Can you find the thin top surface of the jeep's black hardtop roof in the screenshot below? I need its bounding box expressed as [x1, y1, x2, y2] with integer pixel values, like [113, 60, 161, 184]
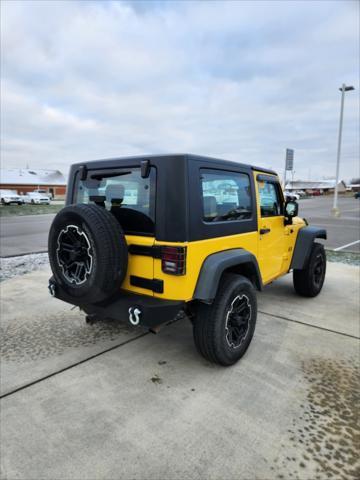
[72, 153, 277, 175]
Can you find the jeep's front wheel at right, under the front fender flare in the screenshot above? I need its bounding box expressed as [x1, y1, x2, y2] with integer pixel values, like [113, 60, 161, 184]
[293, 243, 326, 297]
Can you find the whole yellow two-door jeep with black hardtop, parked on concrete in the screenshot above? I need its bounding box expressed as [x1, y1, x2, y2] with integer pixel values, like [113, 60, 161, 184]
[49, 154, 326, 365]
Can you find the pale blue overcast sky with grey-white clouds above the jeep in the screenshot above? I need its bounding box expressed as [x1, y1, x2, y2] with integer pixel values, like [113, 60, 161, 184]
[1, 0, 359, 180]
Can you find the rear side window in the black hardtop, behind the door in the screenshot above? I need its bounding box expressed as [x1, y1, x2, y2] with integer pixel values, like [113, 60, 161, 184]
[200, 168, 252, 222]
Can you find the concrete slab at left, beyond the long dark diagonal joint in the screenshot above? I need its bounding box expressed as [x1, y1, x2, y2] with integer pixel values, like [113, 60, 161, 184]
[0, 269, 142, 395]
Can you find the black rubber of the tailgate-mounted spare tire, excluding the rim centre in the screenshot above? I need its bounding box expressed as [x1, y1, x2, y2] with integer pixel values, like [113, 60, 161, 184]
[48, 204, 128, 303]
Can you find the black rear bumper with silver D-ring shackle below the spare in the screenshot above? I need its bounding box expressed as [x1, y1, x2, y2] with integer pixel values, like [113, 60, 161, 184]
[49, 277, 185, 328]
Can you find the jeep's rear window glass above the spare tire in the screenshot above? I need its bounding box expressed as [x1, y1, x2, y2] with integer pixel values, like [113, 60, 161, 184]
[75, 167, 156, 235]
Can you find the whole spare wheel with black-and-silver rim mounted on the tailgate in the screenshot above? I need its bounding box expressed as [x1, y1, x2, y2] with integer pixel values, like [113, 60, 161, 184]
[48, 204, 128, 303]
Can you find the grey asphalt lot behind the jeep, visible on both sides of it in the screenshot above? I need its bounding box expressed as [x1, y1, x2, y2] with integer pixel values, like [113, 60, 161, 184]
[0, 196, 360, 257]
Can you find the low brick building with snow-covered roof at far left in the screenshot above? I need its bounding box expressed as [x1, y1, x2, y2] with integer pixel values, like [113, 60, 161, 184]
[0, 168, 66, 199]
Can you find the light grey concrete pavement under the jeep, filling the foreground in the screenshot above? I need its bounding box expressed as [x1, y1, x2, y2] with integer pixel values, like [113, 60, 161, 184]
[0, 263, 360, 480]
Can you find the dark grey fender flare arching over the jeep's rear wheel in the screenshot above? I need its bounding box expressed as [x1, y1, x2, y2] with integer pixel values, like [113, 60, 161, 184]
[193, 248, 263, 302]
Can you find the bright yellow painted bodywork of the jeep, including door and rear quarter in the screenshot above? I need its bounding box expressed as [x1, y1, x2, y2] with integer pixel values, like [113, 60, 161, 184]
[123, 172, 305, 301]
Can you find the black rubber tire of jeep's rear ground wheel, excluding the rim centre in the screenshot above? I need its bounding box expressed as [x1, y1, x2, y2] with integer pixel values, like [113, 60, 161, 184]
[193, 274, 257, 366]
